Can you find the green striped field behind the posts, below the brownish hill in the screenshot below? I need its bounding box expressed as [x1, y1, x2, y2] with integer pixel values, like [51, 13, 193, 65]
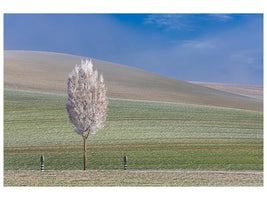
[4, 90, 263, 172]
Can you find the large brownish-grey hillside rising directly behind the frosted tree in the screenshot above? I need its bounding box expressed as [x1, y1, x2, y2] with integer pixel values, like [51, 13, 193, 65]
[4, 51, 263, 111]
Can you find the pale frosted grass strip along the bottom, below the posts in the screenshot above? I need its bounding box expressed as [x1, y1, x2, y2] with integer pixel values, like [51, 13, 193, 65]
[4, 170, 263, 186]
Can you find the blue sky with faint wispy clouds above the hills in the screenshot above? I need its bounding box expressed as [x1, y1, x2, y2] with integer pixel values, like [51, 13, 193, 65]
[4, 14, 263, 85]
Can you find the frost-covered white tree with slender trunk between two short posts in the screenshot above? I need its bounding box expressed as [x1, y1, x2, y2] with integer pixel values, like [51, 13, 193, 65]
[66, 59, 108, 170]
